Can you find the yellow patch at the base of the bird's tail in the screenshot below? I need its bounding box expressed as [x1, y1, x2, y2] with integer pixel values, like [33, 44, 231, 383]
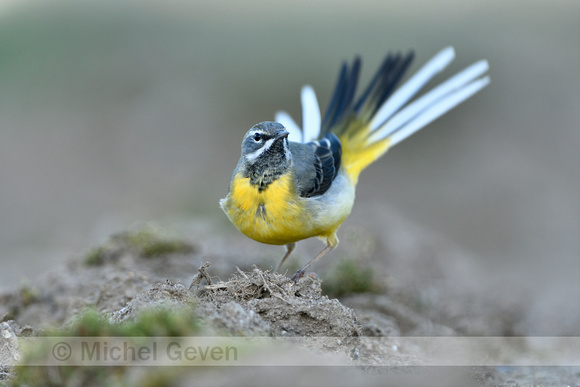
[339, 121, 391, 185]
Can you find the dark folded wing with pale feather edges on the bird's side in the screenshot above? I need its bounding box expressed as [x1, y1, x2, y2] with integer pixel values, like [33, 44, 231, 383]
[299, 133, 342, 198]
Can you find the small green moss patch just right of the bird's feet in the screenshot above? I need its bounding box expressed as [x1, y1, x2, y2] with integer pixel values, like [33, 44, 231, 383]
[322, 258, 381, 297]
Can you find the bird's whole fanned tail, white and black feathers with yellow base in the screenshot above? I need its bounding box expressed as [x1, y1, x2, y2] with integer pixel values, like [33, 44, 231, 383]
[276, 47, 489, 184]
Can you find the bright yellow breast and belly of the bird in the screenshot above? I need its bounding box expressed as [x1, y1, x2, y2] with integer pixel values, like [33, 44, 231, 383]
[220, 175, 328, 245]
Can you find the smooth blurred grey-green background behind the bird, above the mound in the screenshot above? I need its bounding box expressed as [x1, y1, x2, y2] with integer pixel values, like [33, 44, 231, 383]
[0, 0, 580, 326]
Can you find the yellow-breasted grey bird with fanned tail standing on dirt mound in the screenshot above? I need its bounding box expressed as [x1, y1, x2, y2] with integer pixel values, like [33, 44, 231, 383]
[220, 47, 490, 282]
